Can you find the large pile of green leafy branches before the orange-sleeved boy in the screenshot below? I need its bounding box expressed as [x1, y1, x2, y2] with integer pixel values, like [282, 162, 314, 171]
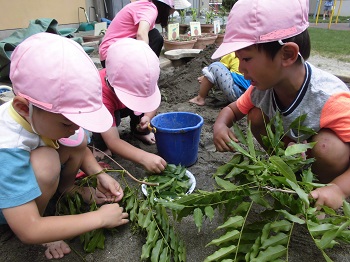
[161, 115, 350, 262]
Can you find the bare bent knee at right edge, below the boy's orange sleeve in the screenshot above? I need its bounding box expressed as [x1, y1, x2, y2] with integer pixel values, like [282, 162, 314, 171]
[311, 129, 350, 183]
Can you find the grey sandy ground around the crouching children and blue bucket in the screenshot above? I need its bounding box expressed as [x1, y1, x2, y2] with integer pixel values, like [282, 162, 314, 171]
[0, 46, 350, 262]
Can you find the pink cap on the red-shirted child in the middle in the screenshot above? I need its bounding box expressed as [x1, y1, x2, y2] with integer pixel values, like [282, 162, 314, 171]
[106, 38, 161, 113]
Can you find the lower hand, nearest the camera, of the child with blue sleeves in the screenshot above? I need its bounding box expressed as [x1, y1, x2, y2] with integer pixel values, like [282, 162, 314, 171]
[96, 204, 129, 228]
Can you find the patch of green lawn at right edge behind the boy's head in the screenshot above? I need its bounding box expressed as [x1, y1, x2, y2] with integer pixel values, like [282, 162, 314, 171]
[308, 27, 350, 62]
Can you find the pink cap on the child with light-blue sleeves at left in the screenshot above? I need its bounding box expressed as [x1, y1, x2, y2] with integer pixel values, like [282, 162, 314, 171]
[10, 33, 112, 132]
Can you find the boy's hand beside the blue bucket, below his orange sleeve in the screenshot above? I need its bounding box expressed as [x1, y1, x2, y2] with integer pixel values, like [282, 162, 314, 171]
[213, 123, 238, 152]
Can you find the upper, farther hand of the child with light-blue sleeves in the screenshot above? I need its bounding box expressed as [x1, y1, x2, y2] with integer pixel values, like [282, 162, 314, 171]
[96, 173, 124, 202]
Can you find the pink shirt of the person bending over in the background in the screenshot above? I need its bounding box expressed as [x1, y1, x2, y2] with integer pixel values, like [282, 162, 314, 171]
[99, 0, 158, 61]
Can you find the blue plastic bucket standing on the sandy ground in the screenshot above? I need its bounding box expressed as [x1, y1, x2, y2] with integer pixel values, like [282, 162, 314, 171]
[151, 112, 204, 167]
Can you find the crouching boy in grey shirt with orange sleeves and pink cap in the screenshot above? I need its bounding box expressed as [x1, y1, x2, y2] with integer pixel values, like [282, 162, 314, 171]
[213, 0, 350, 209]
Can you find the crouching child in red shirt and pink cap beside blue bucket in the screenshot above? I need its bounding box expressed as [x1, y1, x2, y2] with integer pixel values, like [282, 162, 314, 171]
[92, 38, 167, 173]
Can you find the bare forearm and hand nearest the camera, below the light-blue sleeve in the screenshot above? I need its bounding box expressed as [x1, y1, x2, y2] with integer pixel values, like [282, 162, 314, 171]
[2, 201, 129, 244]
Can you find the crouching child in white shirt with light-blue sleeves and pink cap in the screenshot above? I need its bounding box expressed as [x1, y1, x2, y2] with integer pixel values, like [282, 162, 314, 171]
[0, 33, 128, 259]
